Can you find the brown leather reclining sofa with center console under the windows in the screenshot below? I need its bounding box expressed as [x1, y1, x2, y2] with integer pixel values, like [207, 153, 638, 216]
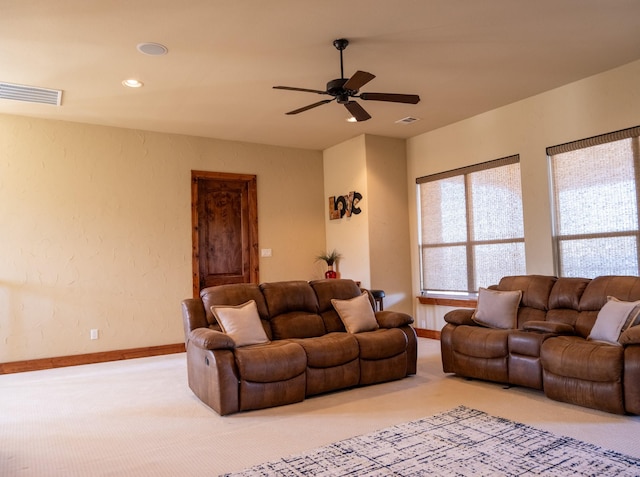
[441, 275, 640, 414]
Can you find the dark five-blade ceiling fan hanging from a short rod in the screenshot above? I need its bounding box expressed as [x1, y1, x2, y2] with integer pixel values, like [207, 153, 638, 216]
[274, 38, 420, 122]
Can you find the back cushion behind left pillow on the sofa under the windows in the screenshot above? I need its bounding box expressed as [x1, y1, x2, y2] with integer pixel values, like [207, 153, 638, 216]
[496, 275, 557, 328]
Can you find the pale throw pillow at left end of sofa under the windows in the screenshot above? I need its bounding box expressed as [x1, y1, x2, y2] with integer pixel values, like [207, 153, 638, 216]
[472, 288, 522, 330]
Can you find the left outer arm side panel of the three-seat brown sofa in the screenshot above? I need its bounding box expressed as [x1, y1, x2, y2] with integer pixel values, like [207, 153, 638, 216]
[187, 344, 240, 416]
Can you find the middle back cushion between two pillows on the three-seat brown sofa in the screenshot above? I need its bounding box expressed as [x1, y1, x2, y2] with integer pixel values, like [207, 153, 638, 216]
[260, 280, 326, 339]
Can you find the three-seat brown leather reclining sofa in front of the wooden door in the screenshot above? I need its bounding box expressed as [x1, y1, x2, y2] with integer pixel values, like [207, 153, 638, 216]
[182, 279, 417, 415]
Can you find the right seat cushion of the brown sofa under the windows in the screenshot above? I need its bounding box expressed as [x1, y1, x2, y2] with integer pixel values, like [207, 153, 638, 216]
[540, 336, 624, 382]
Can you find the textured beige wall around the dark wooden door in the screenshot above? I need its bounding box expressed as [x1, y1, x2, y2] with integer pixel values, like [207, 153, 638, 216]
[0, 116, 326, 362]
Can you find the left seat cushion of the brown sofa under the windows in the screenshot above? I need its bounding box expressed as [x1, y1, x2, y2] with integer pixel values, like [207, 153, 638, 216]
[452, 325, 511, 359]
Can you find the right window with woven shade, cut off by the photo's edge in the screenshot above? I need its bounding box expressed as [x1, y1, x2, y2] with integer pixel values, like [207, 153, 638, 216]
[547, 127, 640, 278]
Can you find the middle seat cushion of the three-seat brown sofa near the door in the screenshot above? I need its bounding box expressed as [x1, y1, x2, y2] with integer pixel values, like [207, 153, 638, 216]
[294, 333, 359, 368]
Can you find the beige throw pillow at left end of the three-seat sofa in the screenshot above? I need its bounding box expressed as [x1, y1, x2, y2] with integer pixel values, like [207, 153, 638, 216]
[211, 300, 269, 347]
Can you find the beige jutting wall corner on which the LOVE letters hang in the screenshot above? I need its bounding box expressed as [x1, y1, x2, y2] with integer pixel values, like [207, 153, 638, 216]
[324, 135, 413, 313]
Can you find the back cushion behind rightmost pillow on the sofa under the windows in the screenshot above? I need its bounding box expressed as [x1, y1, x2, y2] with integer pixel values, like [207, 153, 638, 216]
[575, 275, 640, 338]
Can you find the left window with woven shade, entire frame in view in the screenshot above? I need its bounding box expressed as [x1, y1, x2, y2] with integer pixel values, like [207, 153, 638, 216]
[416, 155, 526, 293]
